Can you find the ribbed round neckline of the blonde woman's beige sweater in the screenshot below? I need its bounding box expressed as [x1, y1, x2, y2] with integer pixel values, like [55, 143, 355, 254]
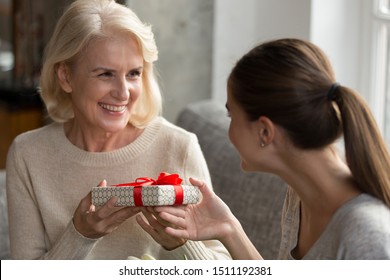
[55, 117, 162, 167]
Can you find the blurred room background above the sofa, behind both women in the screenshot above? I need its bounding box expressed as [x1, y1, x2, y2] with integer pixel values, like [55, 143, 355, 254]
[0, 0, 390, 169]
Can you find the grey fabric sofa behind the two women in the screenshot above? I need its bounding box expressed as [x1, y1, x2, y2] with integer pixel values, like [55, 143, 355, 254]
[0, 100, 286, 259]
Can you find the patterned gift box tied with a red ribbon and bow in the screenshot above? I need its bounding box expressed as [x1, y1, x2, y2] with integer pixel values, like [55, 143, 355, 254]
[92, 173, 201, 206]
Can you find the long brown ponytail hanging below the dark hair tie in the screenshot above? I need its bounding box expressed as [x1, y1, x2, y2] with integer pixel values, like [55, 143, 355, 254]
[334, 86, 390, 207]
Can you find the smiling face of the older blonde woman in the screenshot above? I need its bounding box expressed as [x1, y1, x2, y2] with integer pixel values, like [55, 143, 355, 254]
[62, 32, 143, 132]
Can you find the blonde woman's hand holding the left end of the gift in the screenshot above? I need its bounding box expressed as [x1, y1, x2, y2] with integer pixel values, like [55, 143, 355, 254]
[73, 180, 140, 238]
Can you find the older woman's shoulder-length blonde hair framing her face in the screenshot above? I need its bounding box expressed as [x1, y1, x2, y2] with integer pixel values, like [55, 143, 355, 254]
[40, 0, 162, 127]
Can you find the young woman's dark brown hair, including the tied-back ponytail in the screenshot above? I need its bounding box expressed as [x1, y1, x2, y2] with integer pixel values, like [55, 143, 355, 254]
[228, 39, 390, 206]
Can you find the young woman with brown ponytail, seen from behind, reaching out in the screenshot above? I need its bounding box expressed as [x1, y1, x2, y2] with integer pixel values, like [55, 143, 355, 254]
[153, 39, 390, 259]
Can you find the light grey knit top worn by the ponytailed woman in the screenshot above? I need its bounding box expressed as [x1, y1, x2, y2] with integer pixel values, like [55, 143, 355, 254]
[279, 188, 390, 260]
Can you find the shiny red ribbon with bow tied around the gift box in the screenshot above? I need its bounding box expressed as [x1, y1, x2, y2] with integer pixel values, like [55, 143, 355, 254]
[114, 172, 184, 206]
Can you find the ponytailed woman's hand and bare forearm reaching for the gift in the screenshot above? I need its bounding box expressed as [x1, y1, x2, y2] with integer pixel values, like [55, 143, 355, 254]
[155, 179, 262, 260]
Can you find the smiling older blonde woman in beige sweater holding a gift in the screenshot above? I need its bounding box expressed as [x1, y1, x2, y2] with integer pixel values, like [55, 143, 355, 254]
[7, 0, 230, 259]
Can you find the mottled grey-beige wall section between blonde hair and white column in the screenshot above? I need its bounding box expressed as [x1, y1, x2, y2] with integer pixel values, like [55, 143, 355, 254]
[127, 0, 214, 121]
